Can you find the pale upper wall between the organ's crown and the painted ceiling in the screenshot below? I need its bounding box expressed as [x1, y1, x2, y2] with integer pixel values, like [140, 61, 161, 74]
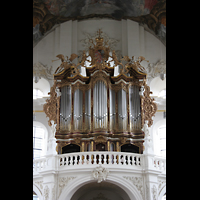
[33, 19, 166, 78]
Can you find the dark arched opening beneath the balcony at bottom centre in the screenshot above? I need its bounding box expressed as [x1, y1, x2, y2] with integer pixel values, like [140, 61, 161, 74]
[71, 182, 130, 200]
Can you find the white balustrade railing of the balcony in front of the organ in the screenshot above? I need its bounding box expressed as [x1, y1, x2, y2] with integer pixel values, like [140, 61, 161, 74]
[33, 151, 166, 173]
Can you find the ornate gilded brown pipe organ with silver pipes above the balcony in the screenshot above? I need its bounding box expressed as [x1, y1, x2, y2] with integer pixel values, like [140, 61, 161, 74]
[43, 30, 157, 154]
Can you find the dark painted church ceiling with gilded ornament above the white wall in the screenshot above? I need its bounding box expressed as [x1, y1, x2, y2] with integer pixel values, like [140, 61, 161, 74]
[33, 0, 166, 46]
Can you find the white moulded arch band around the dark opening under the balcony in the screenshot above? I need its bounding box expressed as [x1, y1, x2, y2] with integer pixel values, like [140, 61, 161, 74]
[58, 175, 143, 200]
